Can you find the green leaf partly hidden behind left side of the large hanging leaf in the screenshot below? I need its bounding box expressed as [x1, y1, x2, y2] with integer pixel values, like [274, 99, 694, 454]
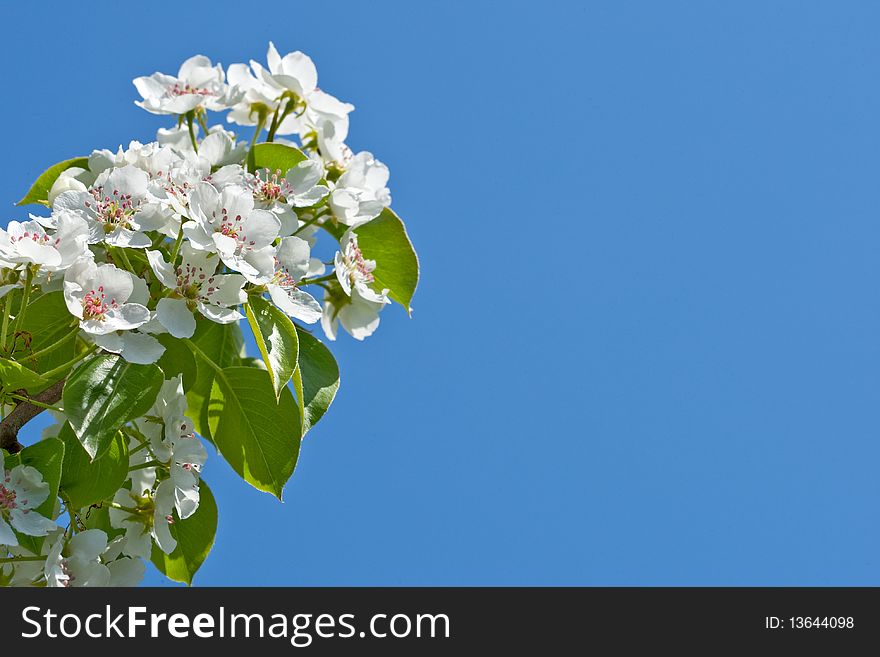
[186, 318, 244, 440]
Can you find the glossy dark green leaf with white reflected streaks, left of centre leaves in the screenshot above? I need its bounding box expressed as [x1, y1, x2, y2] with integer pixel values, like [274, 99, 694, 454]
[62, 354, 164, 460]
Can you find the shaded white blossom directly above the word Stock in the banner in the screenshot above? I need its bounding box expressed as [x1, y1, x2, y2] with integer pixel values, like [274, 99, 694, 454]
[45, 529, 110, 588]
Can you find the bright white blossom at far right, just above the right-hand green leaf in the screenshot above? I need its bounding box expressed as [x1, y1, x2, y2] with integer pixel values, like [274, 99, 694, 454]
[330, 151, 391, 227]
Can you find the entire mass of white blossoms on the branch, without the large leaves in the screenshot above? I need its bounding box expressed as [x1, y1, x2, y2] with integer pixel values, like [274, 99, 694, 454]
[0, 43, 414, 586]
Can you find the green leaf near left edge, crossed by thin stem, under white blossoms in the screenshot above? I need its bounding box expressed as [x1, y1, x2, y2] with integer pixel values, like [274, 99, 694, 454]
[15, 291, 79, 373]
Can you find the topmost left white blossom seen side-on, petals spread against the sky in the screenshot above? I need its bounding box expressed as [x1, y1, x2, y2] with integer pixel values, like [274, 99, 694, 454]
[132, 55, 242, 114]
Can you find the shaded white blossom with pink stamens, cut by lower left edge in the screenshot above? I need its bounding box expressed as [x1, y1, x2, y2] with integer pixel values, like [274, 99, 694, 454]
[0, 450, 56, 546]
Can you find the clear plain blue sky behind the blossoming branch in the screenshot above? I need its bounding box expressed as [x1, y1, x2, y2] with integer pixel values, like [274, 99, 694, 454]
[0, 1, 880, 585]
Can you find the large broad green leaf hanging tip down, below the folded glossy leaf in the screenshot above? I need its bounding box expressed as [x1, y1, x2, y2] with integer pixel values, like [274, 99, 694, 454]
[208, 367, 301, 499]
